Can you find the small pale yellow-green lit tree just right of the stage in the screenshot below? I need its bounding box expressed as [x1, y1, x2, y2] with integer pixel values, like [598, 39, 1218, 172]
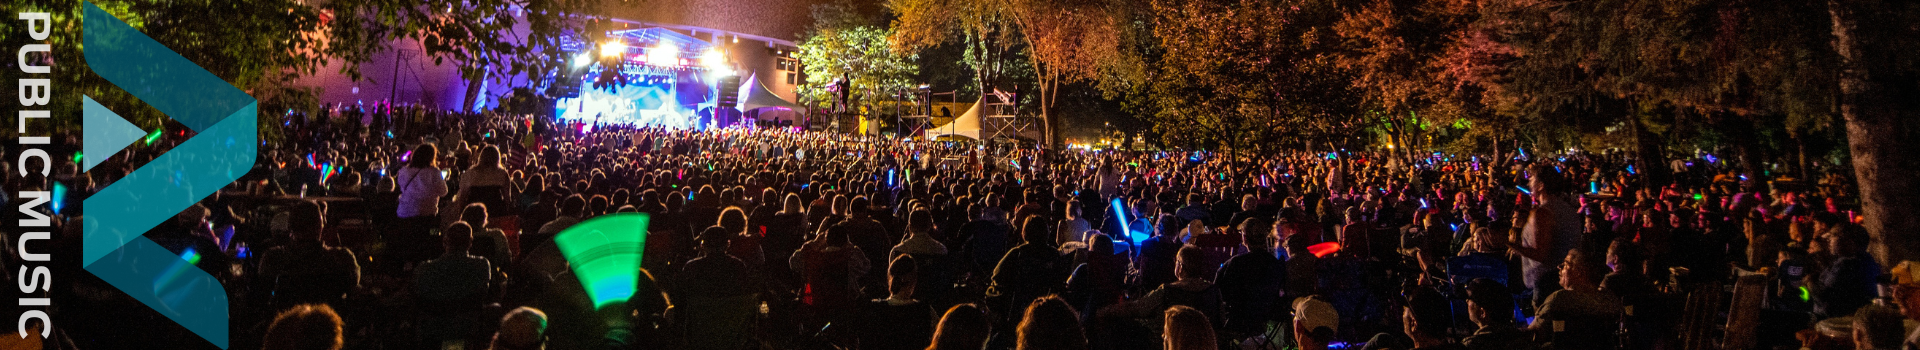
[799, 2, 920, 125]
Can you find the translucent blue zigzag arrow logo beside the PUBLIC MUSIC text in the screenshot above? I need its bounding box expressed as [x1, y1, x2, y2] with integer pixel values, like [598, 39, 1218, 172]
[81, 2, 259, 348]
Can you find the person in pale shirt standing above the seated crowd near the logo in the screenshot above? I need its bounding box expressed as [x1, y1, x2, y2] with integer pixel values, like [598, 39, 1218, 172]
[392, 144, 447, 262]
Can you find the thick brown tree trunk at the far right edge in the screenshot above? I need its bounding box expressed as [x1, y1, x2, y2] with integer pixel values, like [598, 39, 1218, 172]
[1826, 0, 1920, 267]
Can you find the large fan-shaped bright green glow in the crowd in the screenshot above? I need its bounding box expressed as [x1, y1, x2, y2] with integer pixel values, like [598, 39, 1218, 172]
[553, 213, 651, 308]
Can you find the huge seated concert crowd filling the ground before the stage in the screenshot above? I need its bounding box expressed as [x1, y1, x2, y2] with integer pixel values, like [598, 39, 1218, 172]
[0, 106, 1920, 350]
